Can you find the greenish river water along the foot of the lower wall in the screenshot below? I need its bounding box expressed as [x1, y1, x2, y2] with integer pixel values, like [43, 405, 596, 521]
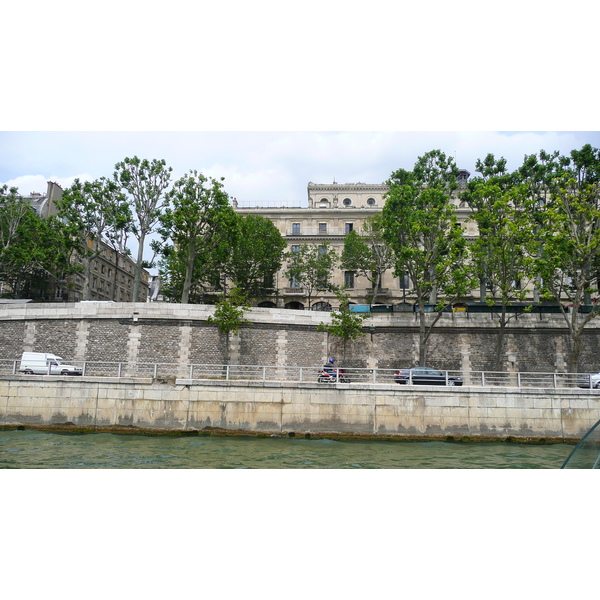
[0, 430, 574, 469]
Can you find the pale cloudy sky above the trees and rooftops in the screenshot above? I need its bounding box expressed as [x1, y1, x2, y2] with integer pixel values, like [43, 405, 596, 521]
[0, 131, 600, 206]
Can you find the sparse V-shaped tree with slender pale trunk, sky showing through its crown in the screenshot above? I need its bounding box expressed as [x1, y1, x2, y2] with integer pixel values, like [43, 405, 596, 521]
[114, 156, 173, 302]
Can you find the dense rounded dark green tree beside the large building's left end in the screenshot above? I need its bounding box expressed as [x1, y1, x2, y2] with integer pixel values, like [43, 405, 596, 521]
[225, 215, 286, 298]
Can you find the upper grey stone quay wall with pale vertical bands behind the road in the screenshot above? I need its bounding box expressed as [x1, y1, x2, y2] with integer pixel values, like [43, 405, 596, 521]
[0, 302, 600, 373]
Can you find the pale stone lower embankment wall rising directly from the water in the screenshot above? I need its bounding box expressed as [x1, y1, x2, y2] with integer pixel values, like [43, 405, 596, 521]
[0, 375, 600, 441]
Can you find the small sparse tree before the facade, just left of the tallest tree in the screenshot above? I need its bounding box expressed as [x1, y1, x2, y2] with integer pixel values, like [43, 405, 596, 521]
[340, 215, 394, 304]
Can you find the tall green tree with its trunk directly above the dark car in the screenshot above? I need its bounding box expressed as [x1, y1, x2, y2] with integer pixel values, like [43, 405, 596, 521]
[382, 150, 473, 365]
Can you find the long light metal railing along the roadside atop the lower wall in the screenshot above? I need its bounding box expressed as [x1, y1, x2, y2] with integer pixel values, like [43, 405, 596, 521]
[0, 359, 600, 389]
